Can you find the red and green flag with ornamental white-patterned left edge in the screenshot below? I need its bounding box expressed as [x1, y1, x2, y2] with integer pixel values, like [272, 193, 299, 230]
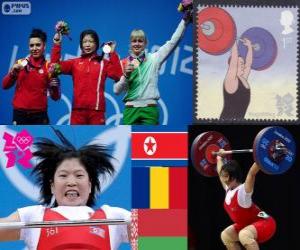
[131, 209, 187, 250]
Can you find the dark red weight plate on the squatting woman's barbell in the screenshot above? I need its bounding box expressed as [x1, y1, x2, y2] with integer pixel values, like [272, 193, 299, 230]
[191, 131, 231, 177]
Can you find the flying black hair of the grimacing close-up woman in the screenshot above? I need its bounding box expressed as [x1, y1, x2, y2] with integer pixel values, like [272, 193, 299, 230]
[32, 129, 115, 206]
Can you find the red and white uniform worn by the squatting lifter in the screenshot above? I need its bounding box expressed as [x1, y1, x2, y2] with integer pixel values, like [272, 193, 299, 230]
[224, 184, 276, 243]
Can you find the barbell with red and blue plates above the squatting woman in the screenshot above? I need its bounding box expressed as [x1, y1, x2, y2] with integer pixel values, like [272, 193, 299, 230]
[191, 126, 296, 177]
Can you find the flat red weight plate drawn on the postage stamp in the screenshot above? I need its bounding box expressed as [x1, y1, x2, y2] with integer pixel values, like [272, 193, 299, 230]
[197, 7, 236, 55]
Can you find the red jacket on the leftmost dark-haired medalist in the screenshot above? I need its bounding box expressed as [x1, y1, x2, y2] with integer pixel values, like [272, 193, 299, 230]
[2, 56, 60, 111]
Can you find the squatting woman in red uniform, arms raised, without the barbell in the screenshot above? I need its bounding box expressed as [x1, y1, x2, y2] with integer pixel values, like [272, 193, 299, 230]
[217, 153, 276, 250]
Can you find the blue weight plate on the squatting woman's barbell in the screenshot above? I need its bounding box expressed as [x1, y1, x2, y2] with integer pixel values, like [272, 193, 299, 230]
[253, 126, 296, 174]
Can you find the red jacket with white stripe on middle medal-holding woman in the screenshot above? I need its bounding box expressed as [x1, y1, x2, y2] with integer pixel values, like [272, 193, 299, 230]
[52, 44, 123, 124]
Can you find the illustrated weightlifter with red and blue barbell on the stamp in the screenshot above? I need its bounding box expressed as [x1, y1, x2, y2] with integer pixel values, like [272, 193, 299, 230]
[197, 7, 277, 119]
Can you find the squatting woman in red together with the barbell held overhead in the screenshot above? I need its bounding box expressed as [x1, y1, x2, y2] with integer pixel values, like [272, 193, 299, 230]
[191, 127, 296, 250]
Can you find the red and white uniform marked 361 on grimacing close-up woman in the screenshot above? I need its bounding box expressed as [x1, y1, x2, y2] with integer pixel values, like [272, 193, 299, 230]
[18, 205, 130, 250]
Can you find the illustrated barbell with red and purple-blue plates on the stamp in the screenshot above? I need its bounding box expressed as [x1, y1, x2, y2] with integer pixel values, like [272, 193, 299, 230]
[197, 7, 278, 70]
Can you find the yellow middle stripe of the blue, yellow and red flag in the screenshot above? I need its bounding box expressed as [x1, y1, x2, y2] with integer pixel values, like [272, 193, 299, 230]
[150, 167, 169, 208]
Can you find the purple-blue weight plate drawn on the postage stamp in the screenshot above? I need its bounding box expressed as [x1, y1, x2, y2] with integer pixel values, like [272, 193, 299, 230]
[238, 27, 278, 70]
